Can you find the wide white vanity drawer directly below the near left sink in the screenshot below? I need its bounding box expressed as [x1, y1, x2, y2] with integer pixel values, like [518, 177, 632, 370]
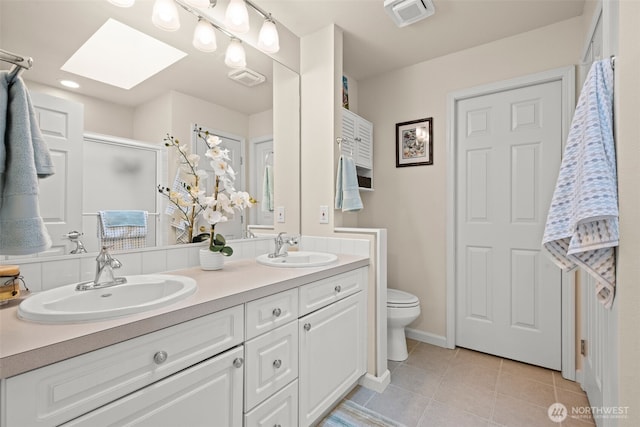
[5, 305, 244, 426]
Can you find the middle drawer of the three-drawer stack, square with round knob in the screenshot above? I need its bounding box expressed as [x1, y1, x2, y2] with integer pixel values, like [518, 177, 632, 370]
[244, 322, 298, 411]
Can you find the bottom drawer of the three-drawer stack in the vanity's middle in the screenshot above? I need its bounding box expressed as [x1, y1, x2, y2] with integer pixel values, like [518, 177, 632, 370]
[244, 380, 298, 427]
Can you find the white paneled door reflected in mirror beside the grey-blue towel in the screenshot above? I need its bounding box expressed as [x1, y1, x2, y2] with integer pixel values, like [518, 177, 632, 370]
[31, 92, 84, 256]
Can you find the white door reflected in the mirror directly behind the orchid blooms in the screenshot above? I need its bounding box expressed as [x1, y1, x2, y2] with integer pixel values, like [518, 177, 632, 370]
[191, 126, 246, 240]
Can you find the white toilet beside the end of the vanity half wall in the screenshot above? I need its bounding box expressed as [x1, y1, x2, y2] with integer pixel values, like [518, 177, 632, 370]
[387, 288, 420, 362]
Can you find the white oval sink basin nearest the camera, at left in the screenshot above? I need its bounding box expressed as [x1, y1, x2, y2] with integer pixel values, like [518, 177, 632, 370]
[18, 274, 197, 323]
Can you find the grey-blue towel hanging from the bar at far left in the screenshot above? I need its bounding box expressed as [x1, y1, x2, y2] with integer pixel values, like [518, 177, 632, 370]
[0, 71, 54, 255]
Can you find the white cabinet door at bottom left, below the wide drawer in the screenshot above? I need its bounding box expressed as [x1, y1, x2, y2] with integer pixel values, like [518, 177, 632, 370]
[63, 346, 243, 427]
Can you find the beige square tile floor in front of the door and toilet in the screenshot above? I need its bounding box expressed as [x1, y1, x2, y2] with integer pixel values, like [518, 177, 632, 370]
[346, 340, 595, 427]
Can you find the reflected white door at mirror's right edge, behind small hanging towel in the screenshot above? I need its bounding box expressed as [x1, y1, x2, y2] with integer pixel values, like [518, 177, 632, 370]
[249, 139, 274, 226]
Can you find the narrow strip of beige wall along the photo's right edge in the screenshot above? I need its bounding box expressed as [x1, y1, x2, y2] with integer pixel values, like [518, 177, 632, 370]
[614, 0, 640, 427]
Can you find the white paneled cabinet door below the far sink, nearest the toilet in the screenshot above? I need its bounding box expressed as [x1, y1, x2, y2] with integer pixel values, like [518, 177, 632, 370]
[298, 292, 367, 426]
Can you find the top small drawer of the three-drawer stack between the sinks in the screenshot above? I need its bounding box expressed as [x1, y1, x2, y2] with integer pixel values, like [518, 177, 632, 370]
[245, 288, 298, 340]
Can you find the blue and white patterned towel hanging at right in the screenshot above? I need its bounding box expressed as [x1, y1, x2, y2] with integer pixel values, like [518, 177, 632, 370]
[542, 59, 618, 308]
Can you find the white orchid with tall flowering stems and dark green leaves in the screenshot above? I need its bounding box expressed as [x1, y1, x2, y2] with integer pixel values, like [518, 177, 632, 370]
[158, 126, 256, 256]
